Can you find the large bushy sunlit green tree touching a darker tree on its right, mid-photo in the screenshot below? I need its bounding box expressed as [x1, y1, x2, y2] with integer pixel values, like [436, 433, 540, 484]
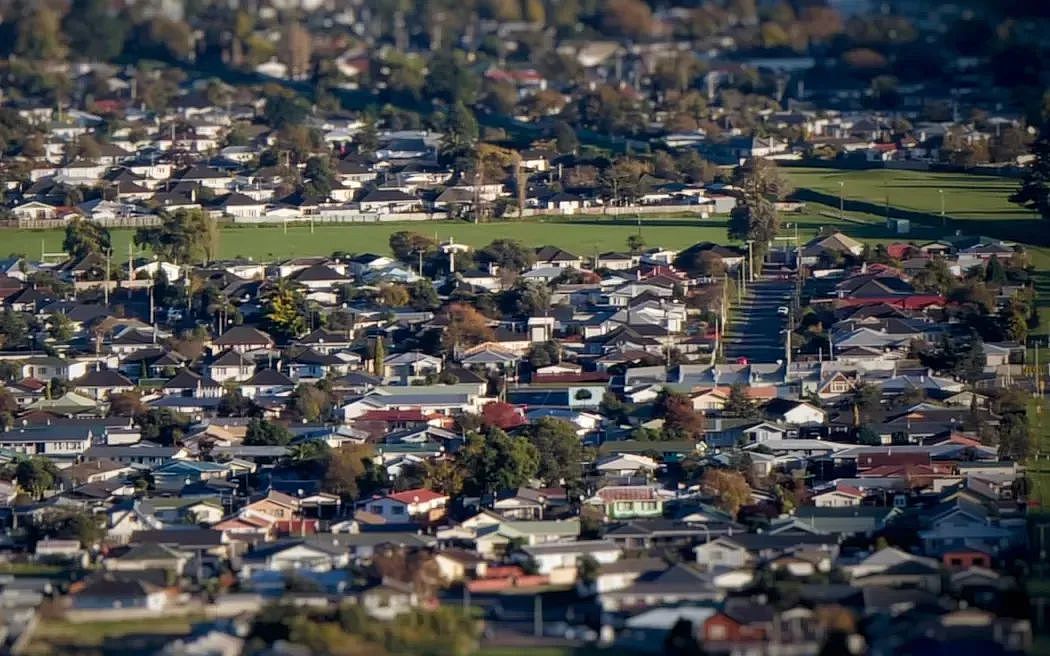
[459, 428, 540, 495]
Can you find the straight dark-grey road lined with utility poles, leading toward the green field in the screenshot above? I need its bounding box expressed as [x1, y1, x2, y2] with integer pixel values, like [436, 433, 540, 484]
[726, 277, 795, 362]
